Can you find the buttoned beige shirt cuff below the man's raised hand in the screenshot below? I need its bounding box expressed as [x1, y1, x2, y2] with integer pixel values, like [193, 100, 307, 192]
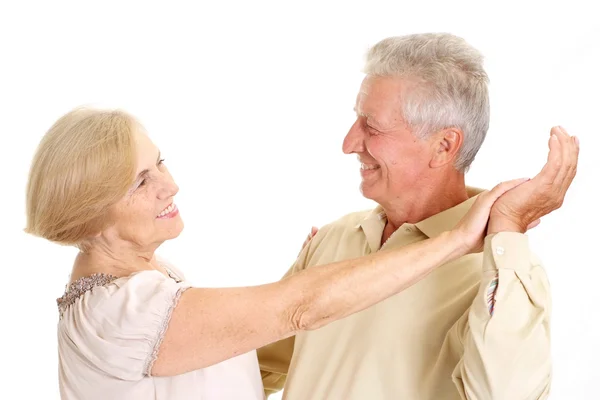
[483, 232, 531, 272]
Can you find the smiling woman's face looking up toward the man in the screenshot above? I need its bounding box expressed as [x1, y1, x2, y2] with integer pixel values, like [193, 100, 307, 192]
[108, 130, 183, 249]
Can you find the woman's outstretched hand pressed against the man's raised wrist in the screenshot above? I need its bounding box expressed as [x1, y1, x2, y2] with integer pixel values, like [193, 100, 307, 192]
[450, 178, 540, 254]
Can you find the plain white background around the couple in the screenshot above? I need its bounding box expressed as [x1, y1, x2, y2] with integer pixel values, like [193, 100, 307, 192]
[0, 0, 600, 400]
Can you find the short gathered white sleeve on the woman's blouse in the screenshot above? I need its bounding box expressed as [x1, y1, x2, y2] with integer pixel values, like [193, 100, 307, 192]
[67, 271, 190, 380]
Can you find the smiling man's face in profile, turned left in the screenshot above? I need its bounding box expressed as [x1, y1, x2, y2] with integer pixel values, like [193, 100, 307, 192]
[343, 76, 432, 205]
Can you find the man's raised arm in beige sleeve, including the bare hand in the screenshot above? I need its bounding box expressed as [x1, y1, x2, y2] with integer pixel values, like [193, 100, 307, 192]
[453, 127, 579, 400]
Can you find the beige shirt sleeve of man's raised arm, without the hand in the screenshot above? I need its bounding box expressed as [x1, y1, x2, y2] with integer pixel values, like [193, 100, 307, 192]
[452, 232, 552, 400]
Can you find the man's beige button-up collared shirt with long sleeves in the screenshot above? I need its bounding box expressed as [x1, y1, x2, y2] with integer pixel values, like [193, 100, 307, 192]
[258, 191, 551, 400]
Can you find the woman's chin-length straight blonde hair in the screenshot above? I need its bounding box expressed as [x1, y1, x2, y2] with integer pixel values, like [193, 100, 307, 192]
[25, 108, 140, 248]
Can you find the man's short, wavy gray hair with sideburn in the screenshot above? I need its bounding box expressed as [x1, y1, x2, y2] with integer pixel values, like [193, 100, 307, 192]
[364, 33, 490, 172]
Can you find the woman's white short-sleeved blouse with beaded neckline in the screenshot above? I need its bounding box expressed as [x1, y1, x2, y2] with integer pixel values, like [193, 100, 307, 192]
[58, 266, 265, 400]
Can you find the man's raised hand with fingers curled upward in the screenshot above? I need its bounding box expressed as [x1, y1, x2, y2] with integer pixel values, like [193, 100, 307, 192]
[488, 127, 579, 235]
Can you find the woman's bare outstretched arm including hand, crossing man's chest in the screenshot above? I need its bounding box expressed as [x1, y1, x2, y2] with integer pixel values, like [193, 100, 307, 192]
[151, 180, 523, 376]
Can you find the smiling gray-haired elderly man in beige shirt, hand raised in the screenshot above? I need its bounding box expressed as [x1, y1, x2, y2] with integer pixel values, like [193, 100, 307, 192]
[259, 34, 579, 400]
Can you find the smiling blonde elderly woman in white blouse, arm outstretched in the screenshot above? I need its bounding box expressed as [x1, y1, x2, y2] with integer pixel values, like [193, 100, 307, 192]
[26, 109, 523, 400]
